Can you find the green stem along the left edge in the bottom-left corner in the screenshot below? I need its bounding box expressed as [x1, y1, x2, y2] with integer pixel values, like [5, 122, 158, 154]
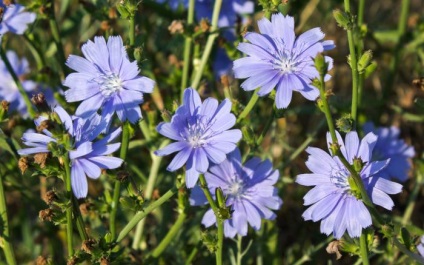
[0, 170, 17, 265]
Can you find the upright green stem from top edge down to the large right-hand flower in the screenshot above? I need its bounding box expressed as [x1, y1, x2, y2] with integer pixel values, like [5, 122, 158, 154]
[344, 0, 359, 128]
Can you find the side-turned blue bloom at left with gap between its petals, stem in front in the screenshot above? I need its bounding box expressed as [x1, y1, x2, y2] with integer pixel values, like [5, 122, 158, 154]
[18, 107, 123, 198]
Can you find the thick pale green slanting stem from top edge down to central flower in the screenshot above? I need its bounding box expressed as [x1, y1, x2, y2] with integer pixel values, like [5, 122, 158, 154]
[191, 0, 222, 89]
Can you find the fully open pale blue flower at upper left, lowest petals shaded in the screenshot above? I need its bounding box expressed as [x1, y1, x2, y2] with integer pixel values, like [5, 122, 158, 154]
[64, 36, 155, 123]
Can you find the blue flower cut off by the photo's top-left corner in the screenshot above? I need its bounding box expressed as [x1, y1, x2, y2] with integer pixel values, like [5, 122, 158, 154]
[0, 0, 36, 35]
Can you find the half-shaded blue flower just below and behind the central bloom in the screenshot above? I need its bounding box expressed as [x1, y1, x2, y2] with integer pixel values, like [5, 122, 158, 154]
[190, 149, 283, 237]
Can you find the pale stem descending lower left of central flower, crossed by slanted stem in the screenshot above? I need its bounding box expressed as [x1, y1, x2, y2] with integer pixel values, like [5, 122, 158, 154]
[132, 140, 169, 249]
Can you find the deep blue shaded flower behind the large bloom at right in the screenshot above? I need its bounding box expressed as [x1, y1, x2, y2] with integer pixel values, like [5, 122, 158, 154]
[364, 122, 415, 182]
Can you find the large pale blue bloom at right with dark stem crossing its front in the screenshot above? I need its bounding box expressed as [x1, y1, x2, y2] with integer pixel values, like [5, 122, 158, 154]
[296, 131, 402, 239]
